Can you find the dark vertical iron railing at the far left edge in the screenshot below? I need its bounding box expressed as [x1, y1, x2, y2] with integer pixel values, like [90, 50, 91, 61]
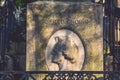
[0, 0, 15, 70]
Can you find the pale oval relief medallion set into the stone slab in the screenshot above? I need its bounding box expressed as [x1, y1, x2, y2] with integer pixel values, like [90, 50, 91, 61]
[46, 29, 85, 71]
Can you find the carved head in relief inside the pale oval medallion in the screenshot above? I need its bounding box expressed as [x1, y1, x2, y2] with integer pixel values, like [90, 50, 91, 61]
[51, 36, 78, 70]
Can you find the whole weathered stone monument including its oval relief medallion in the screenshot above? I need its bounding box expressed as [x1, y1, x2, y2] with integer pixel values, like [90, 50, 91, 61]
[26, 1, 103, 71]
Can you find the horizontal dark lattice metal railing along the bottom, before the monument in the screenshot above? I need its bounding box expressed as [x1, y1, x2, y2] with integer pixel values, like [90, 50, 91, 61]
[0, 71, 120, 80]
